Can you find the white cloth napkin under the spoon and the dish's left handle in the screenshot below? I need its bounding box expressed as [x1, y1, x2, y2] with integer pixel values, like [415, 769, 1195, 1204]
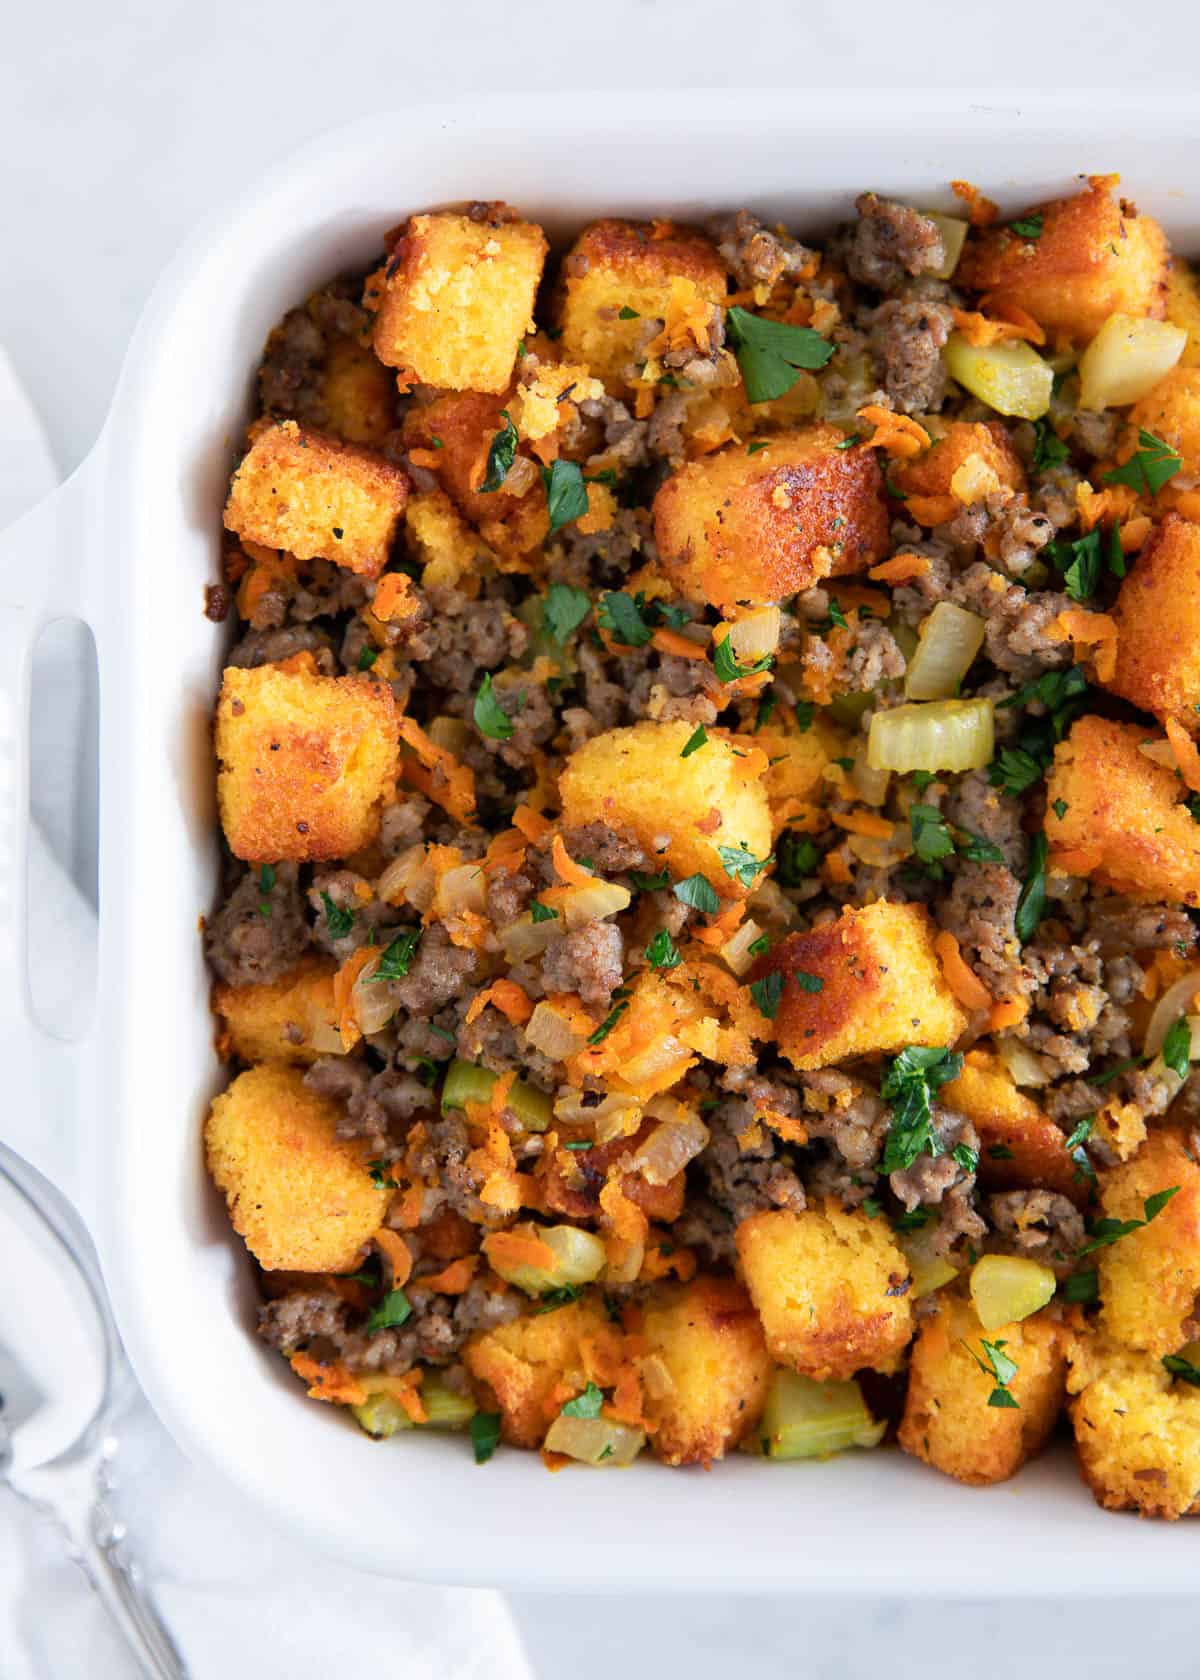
[0, 349, 531, 1680]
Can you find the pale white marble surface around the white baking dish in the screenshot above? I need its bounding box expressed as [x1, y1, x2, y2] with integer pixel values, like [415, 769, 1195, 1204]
[0, 0, 1198, 1680]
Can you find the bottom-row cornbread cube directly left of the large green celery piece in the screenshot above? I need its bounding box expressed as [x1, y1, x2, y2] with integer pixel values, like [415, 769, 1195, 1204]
[642, 1277, 771, 1465]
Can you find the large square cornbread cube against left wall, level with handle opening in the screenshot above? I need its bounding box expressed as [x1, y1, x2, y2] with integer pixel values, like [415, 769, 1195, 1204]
[217, 654, 397, 864]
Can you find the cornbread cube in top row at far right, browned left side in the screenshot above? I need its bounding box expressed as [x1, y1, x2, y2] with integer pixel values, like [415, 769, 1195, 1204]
[955, 176, 1168, 343]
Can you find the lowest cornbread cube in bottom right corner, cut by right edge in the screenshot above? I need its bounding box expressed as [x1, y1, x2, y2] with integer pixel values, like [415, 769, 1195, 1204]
[1067, 1334, 1200, 1522]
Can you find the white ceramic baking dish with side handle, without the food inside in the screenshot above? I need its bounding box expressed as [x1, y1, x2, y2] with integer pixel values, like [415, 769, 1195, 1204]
[0, 89, 1200, 1585]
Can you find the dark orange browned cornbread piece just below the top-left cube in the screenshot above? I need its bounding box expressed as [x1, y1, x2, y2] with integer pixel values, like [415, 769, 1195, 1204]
[403, 391, 550, 554]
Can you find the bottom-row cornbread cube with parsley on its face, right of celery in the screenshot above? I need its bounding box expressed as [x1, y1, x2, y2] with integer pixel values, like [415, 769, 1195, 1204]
[899, 1292, 1066, 1487]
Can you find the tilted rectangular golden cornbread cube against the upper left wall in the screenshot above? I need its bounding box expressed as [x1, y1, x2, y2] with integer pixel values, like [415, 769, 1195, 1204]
[225, 420, 408, 578]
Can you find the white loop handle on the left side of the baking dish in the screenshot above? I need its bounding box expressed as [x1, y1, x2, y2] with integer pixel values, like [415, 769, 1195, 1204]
[0, 455, 99, 1201]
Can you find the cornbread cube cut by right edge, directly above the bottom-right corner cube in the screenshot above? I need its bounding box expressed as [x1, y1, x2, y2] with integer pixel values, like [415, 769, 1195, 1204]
[1096, 1126, 1200, 1356]
